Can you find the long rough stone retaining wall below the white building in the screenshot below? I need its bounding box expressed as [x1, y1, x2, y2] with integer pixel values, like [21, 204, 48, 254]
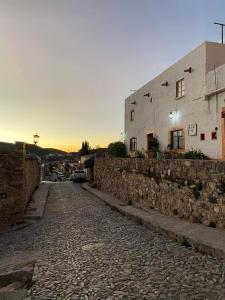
[94, 158, 225, 228]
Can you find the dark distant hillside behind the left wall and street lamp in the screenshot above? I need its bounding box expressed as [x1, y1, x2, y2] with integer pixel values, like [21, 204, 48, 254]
[0, 142, 67, 158]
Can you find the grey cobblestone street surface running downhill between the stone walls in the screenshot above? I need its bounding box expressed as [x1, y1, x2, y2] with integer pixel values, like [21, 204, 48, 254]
[0, 182, 225, 300]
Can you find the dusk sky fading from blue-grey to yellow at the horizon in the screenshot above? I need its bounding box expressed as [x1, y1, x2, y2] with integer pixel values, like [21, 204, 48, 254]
[0, 0, 225, 151]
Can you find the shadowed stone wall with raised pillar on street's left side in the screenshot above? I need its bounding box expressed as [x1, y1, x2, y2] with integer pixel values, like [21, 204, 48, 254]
[0, 143, 40, 230]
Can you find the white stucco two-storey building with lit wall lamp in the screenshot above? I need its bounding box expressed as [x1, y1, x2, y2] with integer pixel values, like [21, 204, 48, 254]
[125, 42, 225, 159]
